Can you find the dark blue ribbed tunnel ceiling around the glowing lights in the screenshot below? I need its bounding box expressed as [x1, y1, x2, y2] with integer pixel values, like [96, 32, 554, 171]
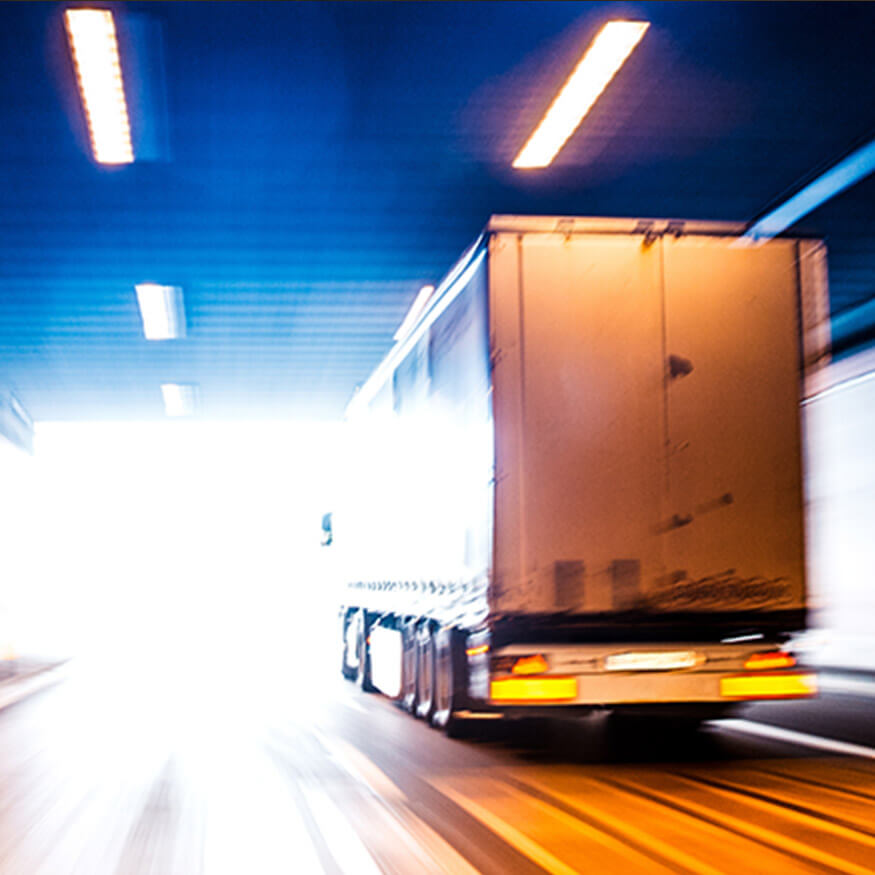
[0, 3, 875, 420]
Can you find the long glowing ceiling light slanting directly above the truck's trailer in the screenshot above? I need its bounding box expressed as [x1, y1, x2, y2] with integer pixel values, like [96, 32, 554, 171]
[513, 21, 650, 169]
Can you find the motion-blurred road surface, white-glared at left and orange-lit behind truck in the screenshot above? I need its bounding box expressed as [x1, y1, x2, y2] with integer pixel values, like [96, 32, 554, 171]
[0, 665, 875, 875]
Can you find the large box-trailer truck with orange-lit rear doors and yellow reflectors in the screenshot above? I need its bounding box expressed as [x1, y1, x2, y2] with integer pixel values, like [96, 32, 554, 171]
[323, 216, 829, 733]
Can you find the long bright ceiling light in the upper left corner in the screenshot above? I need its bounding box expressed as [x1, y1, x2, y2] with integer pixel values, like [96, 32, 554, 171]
[64, 9, 134, 164]
